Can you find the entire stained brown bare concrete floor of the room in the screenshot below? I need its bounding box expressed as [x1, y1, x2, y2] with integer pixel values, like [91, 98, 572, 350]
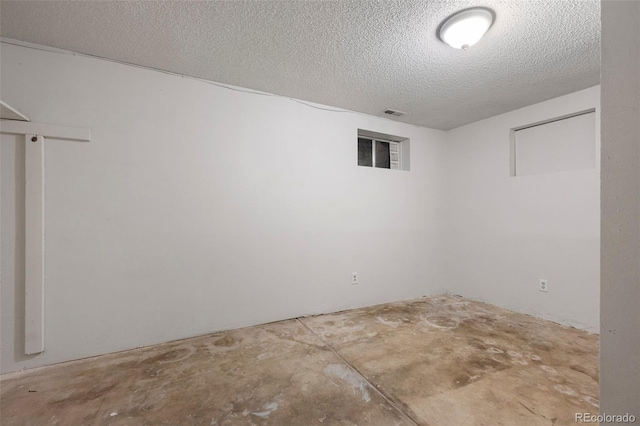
[0, 296, 598, 426]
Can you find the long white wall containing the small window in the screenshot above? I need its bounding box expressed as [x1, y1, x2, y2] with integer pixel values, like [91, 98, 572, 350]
[0, 44, 446, 373]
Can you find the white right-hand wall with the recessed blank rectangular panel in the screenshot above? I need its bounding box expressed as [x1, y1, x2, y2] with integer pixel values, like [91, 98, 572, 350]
[446, 87, 600, 332]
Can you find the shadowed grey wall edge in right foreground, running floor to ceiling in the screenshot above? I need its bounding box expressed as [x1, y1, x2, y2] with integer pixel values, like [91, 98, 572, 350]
[600, 1, 640, 414]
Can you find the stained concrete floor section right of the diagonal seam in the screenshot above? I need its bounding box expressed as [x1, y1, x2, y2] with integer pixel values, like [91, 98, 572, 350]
[302, 295, 598, 426]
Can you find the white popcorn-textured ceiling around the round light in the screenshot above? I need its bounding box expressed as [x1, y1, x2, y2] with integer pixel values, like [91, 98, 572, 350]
[0, 0, 600, 130]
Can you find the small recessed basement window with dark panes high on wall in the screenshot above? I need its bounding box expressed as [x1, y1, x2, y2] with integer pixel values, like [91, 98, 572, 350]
[358, 130, 409, 170]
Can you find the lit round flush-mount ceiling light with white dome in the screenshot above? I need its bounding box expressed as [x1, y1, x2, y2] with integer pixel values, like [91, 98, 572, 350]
[438, 7, 495, 50]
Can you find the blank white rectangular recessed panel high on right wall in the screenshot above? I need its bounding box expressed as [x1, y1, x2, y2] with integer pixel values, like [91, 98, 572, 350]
[512, 110, 596, 176]
